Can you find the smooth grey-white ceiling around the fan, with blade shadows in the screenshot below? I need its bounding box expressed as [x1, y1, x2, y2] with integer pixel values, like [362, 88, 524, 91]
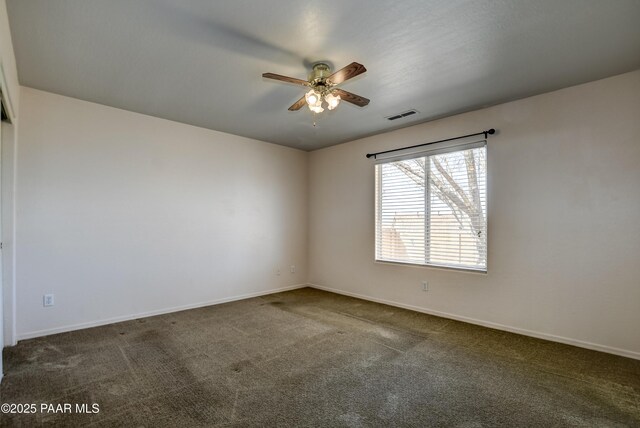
[7, 0, 640, 150]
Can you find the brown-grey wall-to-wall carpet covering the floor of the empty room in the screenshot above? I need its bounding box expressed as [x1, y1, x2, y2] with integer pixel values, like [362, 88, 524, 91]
[0, 288, 640, 428]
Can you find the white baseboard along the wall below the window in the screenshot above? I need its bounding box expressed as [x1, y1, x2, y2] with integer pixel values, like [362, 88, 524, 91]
[307, 284, 640, 360]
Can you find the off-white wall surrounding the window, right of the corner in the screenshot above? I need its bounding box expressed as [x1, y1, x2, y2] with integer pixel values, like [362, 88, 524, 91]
[309, 71, 640, 358]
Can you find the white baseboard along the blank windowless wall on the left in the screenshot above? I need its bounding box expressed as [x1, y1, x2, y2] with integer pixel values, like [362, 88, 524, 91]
[17, 284, 308, 341]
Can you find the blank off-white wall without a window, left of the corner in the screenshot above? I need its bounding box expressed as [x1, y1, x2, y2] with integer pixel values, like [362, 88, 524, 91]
[16, 87, 308, 338]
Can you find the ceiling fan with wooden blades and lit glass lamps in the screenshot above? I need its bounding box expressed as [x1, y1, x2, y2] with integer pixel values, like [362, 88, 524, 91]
[262, 62, 369, 113]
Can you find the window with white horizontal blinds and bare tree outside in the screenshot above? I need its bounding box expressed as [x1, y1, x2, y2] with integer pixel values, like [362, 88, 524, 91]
[376, 141, 487, 271]
